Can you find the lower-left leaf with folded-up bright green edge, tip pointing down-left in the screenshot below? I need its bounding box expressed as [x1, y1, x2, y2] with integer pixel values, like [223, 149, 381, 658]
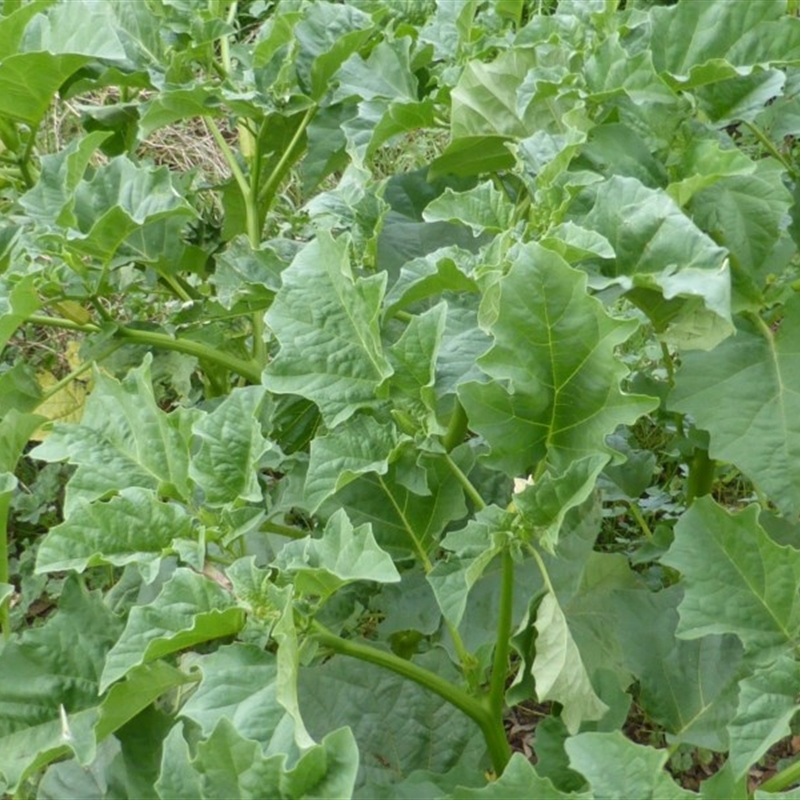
[100, 568, 244, 691]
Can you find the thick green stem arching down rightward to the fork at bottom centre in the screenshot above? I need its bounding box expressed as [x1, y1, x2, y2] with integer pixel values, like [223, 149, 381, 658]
[312, 621, 511, 775]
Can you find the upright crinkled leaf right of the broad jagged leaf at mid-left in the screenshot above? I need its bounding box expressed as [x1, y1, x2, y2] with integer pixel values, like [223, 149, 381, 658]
[189, 386, 277, 507]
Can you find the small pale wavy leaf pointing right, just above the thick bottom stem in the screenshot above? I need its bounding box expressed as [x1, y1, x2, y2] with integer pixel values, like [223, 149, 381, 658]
[274, 510, 400, 600]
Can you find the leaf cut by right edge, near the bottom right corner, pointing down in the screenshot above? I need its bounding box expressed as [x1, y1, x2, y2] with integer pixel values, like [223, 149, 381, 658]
[728, 654, 800, 778]
